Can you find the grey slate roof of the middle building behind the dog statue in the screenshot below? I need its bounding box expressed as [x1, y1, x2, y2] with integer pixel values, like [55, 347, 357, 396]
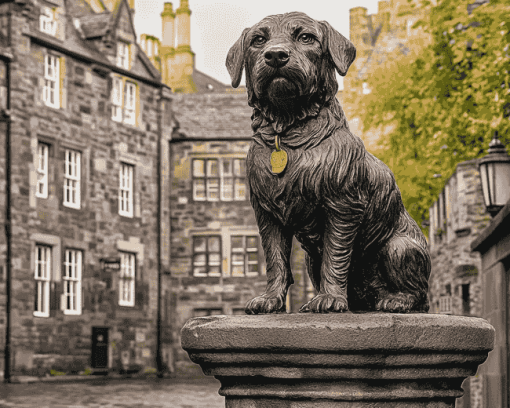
[172, 93, 253, 140]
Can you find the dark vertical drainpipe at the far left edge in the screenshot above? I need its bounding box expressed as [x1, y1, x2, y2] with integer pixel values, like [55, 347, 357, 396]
[0, 5, 12, 383]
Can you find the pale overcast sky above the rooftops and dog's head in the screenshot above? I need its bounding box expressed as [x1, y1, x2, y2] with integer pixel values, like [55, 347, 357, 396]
[134, 0, 378, 87]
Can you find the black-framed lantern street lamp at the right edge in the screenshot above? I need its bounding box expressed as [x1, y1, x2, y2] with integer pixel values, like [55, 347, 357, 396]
[480, 130, 510, 217]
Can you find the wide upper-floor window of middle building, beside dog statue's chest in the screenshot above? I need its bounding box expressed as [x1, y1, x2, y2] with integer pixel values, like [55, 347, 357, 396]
[193, 158, 246, 201]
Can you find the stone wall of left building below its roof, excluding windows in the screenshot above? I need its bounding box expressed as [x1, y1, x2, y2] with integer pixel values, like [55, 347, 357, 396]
[0, 0, 171, 375]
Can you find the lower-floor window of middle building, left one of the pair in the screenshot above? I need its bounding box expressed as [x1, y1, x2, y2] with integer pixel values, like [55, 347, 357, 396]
[193, 235, 221, 276]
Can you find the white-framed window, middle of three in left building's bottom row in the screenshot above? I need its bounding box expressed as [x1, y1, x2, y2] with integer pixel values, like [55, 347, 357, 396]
[61, 249, 82, 315]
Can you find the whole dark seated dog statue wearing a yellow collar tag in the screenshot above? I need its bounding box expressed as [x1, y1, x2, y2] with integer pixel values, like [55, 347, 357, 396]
[226, 12, 430, 314]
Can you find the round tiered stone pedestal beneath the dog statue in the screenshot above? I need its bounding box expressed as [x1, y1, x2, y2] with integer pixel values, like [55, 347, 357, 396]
[182, 313, 494, 408]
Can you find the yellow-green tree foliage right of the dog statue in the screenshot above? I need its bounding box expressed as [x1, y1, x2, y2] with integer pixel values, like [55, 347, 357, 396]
[344, 0, 510, 230]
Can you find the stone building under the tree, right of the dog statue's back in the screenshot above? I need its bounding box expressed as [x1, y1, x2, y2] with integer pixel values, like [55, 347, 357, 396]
[429, 160, 490, 408]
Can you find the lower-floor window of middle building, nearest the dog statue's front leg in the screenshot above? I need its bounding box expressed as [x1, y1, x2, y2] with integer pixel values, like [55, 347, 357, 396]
[230, 235, 259, 276]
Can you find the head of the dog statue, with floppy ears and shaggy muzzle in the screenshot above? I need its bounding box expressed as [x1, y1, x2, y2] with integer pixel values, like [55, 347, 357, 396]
[226, 12, 356, 133]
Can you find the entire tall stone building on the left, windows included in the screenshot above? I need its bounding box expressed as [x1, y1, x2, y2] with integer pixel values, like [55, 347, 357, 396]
[0, 0, 172, 377]
